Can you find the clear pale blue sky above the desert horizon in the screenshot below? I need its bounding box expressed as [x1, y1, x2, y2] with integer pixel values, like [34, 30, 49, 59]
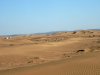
[0, 0, 100, 35]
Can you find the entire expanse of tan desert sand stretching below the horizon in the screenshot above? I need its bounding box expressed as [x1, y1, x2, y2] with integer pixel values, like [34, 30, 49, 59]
[0, 30, 100, 75]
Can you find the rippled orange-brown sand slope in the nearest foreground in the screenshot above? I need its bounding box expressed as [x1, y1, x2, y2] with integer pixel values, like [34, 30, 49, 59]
[0, 52, 100, 75]
